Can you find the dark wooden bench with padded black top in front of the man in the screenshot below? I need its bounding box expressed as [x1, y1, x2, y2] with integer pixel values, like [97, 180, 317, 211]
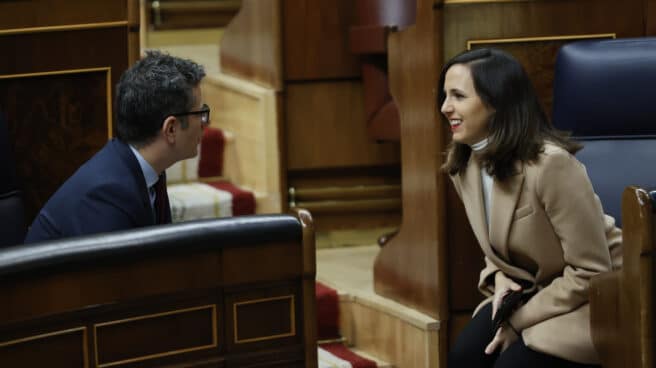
[0, 211, 317, 367]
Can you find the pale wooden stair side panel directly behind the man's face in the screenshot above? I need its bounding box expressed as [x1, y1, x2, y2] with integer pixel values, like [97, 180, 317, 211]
[201, 74, 283, 213]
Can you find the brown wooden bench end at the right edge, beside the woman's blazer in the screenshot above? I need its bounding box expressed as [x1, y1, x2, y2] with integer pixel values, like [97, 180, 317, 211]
[590, 186, 656, 368]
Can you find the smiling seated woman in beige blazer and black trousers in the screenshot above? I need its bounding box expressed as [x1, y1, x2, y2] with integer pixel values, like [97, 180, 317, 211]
[439, 49, 621, 368]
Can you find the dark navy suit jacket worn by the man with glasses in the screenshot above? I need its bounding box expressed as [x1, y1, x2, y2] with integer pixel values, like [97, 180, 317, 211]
[25, 139, 171, 243]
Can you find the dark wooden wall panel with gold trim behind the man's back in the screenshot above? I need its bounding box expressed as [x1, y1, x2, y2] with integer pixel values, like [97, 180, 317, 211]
[0, 18, 133, 224]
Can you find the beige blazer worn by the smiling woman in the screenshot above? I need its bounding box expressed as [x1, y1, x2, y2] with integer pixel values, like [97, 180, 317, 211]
[451, 144, 622, 364]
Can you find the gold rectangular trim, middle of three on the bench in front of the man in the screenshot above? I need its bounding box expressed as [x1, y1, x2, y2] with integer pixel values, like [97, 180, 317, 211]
[93, 304, 218, 368]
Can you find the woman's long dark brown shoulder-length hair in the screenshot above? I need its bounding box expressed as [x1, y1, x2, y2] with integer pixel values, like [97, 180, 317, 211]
[438, 48, 582, 181]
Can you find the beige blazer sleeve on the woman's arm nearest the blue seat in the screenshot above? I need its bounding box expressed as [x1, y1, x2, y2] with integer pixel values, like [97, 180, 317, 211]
[510, 151, 611, 329]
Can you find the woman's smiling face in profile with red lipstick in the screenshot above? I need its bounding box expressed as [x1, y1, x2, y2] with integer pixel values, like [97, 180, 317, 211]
[440, 64, 494, 146]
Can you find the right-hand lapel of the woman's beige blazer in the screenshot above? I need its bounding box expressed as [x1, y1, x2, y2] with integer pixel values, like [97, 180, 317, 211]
[490, 167, 524, 259]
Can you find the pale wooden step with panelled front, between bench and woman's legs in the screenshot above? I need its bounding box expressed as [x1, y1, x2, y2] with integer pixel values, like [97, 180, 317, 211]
[317, 245, 444, 368]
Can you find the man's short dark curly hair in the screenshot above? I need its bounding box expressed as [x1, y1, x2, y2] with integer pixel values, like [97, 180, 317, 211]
[114, 51, 205, 146]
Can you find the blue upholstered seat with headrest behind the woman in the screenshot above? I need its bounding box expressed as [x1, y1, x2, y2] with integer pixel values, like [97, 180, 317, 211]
[553, 37, 656, 226]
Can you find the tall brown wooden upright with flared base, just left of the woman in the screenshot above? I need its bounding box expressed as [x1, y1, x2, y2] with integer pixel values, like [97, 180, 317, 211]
[374, 0, 448, 322]
